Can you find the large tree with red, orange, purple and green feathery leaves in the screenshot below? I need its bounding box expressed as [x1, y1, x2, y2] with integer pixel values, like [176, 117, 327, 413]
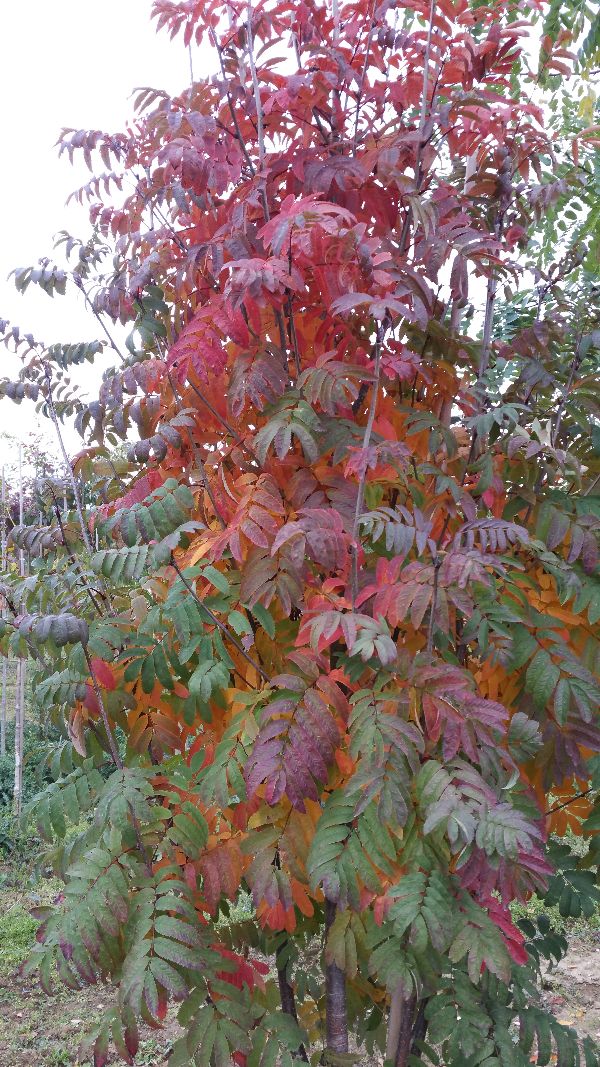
[3, 0, 600, 1067]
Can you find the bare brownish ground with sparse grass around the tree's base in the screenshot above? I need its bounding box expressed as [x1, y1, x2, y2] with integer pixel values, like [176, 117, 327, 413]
[0, 865, 600, 1067]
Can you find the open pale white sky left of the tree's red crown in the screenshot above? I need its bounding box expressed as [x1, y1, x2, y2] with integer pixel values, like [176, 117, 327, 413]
[0, 0, 200, 462]
